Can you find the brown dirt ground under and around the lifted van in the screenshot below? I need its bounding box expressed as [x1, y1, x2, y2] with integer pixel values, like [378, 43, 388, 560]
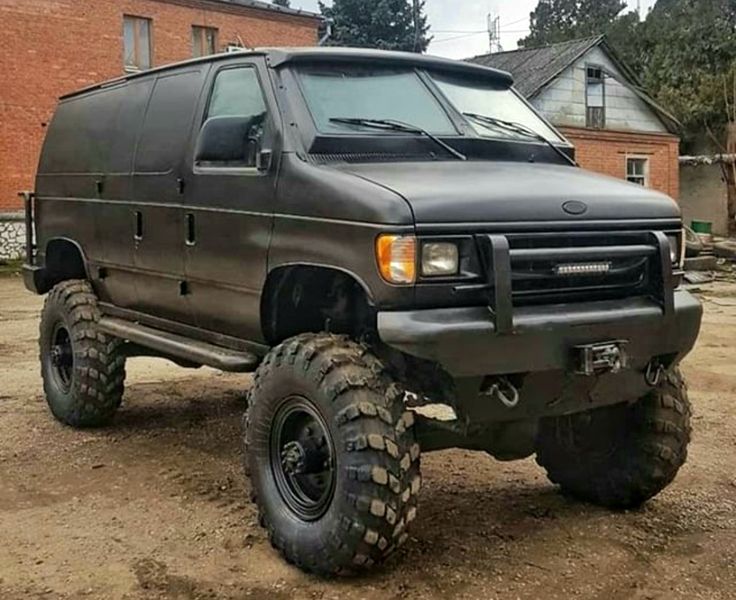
[0, 277, 736, 600]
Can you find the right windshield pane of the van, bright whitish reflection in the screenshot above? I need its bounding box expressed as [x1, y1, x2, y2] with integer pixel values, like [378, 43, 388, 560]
[430, 73, 564, 144]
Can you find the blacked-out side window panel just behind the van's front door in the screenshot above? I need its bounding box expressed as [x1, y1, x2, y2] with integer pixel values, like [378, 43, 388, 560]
[135, 71, 202, 173]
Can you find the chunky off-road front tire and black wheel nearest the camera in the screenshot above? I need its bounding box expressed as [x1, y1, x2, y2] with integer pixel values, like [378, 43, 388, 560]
[244, 334, 421, 576]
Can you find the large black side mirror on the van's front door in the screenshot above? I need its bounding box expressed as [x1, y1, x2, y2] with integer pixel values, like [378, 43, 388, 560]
[194, 115, 265, 167]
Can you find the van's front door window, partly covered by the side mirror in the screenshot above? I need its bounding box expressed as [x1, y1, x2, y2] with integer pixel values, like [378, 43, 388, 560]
[197, 67, 268, 168]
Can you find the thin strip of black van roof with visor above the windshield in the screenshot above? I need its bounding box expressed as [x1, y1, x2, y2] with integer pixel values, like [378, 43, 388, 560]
[60, 47, 514, 100]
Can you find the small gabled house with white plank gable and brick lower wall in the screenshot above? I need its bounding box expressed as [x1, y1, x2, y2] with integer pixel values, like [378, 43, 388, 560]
[470, 36, 680, 199]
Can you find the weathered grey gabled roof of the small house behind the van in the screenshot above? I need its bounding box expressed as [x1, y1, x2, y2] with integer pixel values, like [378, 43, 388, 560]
[468, 35, 680, 133]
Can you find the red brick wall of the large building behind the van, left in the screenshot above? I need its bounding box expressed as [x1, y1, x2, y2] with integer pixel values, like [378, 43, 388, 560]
[0, 0, 318, 212]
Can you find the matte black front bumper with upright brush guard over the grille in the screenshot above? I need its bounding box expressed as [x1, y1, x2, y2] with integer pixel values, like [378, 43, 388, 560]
[378, 231, 702, 378]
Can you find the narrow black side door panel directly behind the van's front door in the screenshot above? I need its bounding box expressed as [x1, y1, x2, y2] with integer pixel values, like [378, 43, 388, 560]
[130, 65, 208, 323]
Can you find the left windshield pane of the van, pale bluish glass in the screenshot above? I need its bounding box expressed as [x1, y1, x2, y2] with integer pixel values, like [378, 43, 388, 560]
[299, 65, 458, 135]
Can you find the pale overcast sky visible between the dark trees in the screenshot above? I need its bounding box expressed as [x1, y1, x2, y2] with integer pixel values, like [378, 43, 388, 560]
[291, 0, 655, 58]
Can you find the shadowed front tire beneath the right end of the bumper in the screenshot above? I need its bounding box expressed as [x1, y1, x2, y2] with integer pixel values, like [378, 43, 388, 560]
[537, 369, 691, 509]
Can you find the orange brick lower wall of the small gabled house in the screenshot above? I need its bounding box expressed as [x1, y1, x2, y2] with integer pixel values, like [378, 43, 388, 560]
[560, 127, 680, 200]
